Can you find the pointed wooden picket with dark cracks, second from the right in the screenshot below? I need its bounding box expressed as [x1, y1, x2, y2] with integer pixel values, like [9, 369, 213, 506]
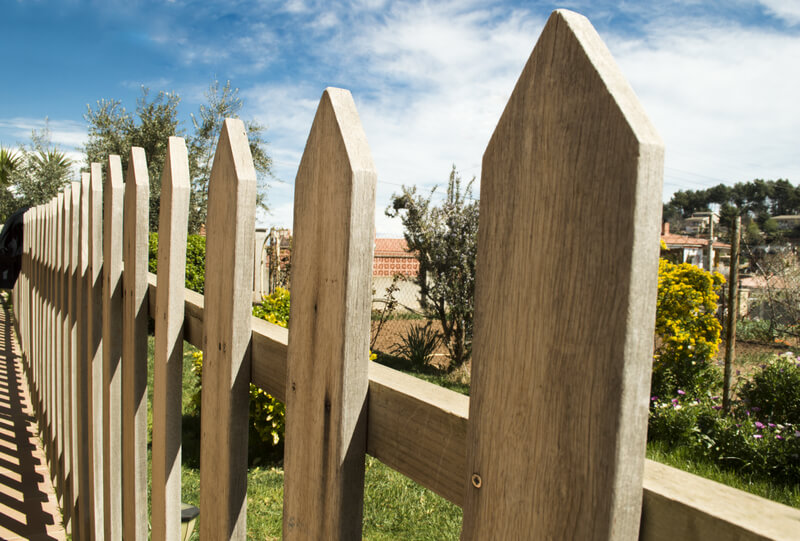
[283, 88, 377, 540]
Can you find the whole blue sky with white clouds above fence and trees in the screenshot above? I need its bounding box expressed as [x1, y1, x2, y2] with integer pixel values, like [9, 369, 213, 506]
[0, 0, 800, 236]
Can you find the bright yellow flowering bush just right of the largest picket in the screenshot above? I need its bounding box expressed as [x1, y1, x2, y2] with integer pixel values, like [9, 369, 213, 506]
[652, 258, 725, 396]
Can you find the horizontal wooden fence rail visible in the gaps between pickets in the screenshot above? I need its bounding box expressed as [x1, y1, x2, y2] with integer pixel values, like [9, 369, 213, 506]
[149, 274, 800, 541]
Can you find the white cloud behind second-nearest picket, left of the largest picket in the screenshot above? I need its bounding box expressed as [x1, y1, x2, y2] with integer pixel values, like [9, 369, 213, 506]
[245, 4, 542, 236]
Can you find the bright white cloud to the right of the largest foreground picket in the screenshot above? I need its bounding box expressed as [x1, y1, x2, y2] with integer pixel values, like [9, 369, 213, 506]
[610, 21, 800, 192]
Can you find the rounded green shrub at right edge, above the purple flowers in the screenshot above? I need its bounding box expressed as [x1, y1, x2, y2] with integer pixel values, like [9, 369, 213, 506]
[739, 353, 800, 425]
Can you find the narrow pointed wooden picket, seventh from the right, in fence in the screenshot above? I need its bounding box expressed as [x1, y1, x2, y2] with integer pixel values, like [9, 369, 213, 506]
[86, 163, 105, 541]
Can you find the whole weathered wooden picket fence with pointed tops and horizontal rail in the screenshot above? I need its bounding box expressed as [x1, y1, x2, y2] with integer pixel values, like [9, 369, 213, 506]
[7, 11, 800, 540]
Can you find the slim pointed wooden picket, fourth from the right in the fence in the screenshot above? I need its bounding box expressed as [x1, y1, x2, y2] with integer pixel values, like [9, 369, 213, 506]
[151, 137, 190, 541]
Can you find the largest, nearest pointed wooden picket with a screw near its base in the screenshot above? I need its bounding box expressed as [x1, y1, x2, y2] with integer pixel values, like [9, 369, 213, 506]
[462, 11, 663, 540]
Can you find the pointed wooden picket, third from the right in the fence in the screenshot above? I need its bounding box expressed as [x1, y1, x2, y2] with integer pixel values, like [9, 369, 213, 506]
[200, 119, 256, 540]
